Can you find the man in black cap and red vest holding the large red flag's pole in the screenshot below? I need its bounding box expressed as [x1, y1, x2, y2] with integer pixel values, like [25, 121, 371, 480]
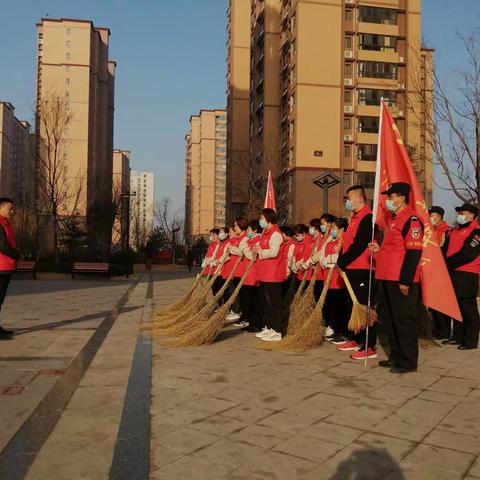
[369, 182, 424, 373]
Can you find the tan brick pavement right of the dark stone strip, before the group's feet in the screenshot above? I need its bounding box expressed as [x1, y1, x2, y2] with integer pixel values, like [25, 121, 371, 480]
[150, 272, 480, 480]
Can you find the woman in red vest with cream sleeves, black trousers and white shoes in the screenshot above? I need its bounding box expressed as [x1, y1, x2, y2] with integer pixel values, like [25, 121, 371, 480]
[252, 208, 286, 342]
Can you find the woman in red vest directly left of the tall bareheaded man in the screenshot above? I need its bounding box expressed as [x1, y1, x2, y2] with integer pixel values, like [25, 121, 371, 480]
[322, 218, 350, 344]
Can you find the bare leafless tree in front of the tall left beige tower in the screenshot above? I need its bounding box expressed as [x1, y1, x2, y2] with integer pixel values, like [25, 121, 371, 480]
[36, 90, 86, 263]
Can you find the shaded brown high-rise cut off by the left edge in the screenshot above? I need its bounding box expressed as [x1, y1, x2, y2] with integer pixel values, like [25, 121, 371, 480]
[0, 102, 35, 208]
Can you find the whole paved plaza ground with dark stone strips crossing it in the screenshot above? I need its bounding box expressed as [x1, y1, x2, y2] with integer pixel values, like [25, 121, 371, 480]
[0, 270, 480, 480]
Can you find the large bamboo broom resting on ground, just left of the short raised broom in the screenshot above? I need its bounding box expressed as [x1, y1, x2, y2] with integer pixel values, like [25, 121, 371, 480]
[262, 268, 333, 352]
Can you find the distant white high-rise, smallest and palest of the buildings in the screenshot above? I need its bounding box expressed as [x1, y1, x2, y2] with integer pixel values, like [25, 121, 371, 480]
[130, 171, 155, 249]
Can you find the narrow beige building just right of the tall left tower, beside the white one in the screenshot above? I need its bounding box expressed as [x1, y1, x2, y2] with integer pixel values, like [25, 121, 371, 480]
[112, 149, 130, 248]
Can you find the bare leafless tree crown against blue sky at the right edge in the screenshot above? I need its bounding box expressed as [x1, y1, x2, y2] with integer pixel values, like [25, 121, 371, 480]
[408, 33, 480, 205]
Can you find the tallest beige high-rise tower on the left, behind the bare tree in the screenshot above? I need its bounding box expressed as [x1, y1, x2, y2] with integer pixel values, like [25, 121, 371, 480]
[36, 18, 115, 248]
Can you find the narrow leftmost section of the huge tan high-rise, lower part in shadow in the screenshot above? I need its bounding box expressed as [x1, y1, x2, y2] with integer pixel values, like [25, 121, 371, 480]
[227, 0, 251, 222]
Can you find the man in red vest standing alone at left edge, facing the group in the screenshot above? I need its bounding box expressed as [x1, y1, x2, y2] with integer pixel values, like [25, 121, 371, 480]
[0, 197, 20, 340]
